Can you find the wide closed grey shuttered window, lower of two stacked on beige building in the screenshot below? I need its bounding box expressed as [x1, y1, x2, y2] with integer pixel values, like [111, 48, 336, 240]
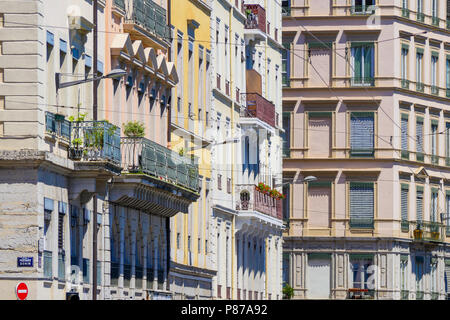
[350, 182, 374, 229]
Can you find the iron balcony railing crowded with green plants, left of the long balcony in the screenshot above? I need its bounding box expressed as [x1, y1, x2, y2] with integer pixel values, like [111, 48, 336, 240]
[70, 121, 121, 165]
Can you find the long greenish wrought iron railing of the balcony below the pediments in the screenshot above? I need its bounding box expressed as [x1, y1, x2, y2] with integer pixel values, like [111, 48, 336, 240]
[122, 137, 199, 192]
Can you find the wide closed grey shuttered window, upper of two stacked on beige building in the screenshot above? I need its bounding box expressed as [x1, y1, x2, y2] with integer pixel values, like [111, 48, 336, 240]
[350, 112, 374, 157]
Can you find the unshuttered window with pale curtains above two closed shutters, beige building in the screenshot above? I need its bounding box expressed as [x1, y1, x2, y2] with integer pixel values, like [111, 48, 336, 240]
[351, 42, 375, 86]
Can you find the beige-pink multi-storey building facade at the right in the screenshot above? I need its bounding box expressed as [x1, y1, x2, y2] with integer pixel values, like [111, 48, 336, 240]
[283, 0, 450, 300]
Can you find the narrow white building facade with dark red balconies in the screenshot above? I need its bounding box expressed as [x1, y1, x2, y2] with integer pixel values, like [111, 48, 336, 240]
[211, 0, 282, 300]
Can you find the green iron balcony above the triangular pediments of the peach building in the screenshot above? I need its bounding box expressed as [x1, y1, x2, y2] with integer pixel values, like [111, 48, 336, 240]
[124, 0, 170, 43]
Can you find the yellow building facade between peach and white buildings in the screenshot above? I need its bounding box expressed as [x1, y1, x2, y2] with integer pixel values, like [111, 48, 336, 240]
[169, 0, 215, 299]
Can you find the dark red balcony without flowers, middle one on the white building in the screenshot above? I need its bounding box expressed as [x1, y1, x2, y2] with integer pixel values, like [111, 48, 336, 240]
[241, 93, 275, 128]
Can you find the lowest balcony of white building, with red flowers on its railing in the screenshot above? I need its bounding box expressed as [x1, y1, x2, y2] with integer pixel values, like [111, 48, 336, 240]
[236, 185, 283, 220]
